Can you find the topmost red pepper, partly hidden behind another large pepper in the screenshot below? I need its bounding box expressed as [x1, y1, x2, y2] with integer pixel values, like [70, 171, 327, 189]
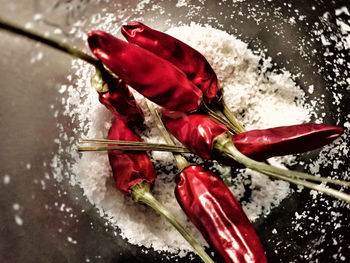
[121, 22, 222, 104]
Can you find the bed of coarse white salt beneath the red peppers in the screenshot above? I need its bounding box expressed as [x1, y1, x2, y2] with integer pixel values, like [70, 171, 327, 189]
[51, 24, 348, 253]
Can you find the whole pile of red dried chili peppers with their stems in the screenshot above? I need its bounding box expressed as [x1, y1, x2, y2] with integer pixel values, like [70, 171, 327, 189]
[0, 21, 350, 262]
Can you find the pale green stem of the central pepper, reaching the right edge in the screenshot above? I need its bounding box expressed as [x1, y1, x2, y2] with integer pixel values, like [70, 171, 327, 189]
[214, 134, 350, 203]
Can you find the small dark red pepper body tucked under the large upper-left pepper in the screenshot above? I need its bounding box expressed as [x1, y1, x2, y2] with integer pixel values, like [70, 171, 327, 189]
[98, 79, 144, 127]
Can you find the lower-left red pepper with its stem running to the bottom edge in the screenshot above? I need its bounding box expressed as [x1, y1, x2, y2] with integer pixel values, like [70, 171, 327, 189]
[108, 119, 214, 263]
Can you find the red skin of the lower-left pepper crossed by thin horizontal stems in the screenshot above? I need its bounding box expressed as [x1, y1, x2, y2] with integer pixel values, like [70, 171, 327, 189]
[108, 119, 156, 195]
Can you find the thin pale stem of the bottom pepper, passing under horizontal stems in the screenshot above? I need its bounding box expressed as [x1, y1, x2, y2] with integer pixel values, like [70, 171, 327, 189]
[147, 100, 190, 171]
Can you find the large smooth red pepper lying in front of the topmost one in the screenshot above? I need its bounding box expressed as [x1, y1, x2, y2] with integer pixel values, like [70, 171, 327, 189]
[88, 31, 203, 112]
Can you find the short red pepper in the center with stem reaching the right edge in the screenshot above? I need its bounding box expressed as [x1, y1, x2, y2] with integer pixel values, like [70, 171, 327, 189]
[163, 110, 350, 203]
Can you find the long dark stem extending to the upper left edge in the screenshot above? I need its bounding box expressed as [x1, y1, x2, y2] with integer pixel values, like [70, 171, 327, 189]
[0, 18, 106, 72]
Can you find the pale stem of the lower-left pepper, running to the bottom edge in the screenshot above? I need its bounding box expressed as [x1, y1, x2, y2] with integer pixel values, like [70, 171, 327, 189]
[131, 182, 214, 263]
